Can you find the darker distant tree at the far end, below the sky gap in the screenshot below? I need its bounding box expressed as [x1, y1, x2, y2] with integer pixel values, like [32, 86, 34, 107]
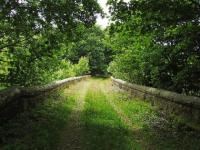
[66, 26, 114, 75]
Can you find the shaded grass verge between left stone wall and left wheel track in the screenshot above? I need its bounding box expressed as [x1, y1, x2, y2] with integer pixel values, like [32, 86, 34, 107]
[0, 91, 75, 150]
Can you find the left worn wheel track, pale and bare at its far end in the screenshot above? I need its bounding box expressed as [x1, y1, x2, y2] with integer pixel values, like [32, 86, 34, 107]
[58, 81, 90, 150]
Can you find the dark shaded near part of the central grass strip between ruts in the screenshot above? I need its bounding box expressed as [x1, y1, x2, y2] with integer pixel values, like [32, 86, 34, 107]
[82, 102, 141, 150]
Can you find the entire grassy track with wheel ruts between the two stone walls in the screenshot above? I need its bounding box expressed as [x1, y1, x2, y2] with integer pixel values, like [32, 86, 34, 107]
[0, 78, 200, 150]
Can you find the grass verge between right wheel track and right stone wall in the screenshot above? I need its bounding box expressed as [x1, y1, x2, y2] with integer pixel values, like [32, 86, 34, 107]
[109, 85, 200, 150]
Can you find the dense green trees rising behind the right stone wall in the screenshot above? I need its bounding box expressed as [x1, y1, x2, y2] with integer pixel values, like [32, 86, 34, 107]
[109, 0, 200, 96]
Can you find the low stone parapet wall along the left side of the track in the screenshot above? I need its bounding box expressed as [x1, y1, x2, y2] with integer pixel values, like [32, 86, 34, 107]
[0, 75, 90, 119]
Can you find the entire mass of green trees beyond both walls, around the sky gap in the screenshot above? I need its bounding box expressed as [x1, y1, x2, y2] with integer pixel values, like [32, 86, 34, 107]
[0, 0, 200, 96]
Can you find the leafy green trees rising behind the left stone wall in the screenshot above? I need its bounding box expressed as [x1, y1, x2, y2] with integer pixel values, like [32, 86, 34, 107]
[0, 0, 102, 86]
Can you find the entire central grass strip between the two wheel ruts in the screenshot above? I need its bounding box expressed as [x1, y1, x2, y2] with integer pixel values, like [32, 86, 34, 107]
[82, 84, 140, 150]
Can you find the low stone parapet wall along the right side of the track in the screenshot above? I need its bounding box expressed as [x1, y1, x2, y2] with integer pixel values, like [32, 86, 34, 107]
[111, 77, 200, 125]
